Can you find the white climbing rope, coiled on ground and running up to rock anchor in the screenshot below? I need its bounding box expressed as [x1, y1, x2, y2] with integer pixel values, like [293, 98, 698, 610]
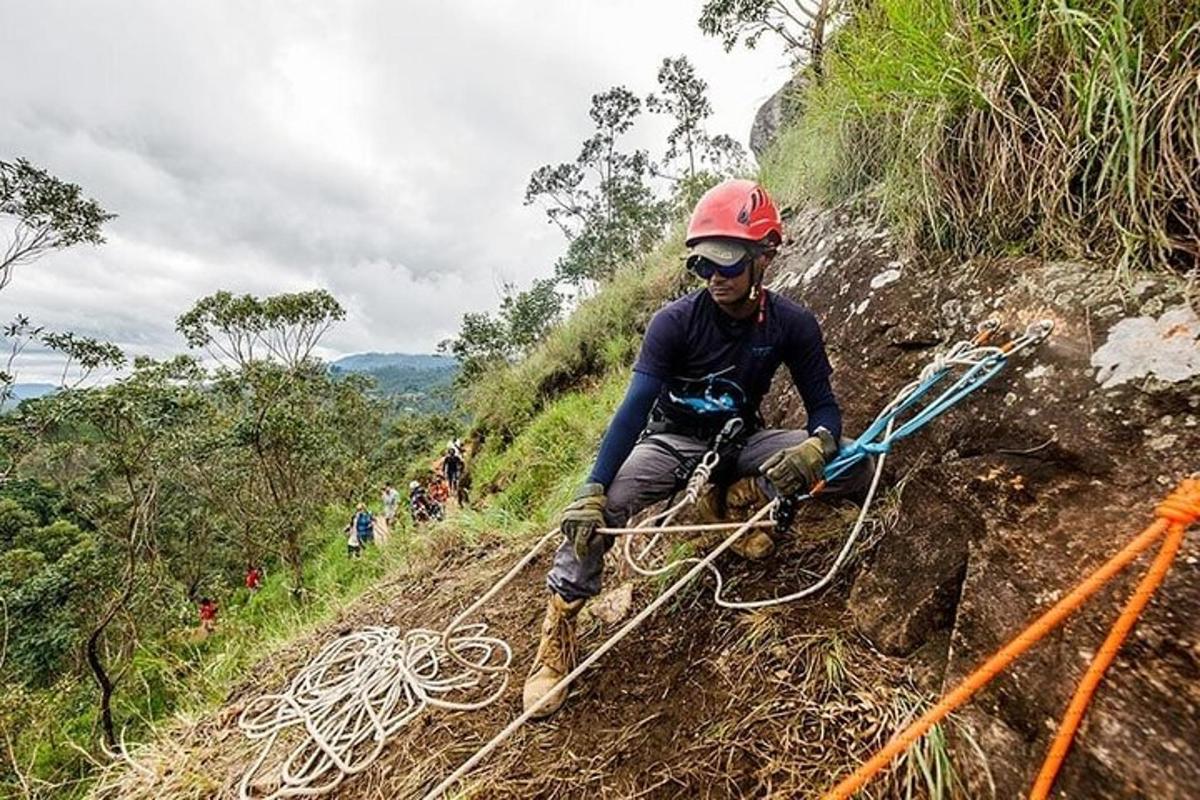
[231, 321, 1052, 800]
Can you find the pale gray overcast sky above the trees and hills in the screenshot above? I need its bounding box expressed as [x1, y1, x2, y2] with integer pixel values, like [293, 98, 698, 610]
[0, 0, 787, 381]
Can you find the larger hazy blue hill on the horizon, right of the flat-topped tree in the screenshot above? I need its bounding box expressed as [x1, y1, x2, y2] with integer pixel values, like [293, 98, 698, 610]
[329, 353, 458, 411]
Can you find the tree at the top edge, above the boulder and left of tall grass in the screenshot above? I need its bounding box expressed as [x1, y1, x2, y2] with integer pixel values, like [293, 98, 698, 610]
[700, 0, 840, 77]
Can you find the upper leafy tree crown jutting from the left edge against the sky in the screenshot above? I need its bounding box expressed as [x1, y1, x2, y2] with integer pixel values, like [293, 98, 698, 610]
[0, 158, 116, 289]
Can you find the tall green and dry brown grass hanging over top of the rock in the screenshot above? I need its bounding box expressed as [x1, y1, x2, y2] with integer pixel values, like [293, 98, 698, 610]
[763, 0, 1200, 270]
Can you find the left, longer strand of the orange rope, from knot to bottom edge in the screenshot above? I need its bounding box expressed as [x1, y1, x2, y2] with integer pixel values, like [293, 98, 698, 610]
[823, 479, 1200, 800]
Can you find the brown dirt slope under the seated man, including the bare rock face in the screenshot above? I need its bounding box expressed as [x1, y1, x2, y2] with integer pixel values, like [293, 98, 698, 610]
[102, 203, 1200, 800]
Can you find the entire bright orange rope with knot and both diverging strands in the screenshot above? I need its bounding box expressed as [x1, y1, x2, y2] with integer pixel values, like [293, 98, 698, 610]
[822, 479, 1200, 800]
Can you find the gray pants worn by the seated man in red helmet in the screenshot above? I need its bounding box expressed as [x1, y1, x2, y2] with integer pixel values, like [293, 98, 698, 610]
[546, 428, 872, 602]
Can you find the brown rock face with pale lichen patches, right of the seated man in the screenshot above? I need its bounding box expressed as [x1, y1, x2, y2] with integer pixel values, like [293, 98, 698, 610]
[764, 201, 1200, 800]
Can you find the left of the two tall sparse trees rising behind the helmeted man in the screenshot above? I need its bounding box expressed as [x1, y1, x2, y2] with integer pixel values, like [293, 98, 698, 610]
[526, 86, 667, 287]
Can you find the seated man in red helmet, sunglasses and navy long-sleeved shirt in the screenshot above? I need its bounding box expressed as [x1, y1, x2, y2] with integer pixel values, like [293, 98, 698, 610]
[524, 180, 870, 716]
